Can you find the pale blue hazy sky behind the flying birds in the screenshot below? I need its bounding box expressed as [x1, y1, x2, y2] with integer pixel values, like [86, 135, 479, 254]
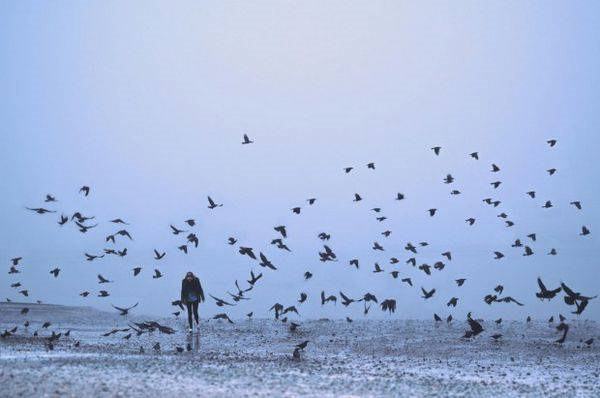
[0, 1, 600, 319]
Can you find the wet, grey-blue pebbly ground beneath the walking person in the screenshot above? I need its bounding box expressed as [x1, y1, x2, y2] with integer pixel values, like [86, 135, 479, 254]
[0, 303, 600, 397]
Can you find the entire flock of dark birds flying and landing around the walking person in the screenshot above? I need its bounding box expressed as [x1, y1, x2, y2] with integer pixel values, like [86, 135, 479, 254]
[0, 135, 596, 358]
